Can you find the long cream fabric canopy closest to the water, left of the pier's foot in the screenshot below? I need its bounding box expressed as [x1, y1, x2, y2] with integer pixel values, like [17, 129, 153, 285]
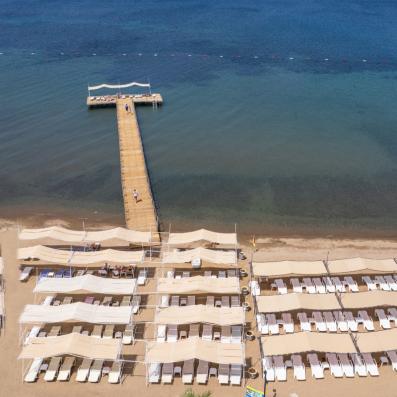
[19, 226, 151, 244]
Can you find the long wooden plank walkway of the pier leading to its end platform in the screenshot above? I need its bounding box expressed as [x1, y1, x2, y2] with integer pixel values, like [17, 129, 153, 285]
[116, 98, 159, 241]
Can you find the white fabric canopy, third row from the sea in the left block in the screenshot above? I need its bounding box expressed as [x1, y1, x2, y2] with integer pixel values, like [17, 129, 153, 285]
[33, 274, 136, 295]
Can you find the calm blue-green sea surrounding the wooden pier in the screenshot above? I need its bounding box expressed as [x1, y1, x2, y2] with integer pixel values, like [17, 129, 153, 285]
[0, 0, 397, 237]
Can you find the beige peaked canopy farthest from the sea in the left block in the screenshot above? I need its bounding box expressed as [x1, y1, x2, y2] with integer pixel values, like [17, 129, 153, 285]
[18, 333, 121, 360]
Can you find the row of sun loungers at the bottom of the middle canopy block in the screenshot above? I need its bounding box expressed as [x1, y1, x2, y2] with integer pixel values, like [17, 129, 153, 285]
[149, 360, 243, 385]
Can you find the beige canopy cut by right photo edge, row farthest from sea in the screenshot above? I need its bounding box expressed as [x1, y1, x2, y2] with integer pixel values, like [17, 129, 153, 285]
[357, 328, 397, 353]
